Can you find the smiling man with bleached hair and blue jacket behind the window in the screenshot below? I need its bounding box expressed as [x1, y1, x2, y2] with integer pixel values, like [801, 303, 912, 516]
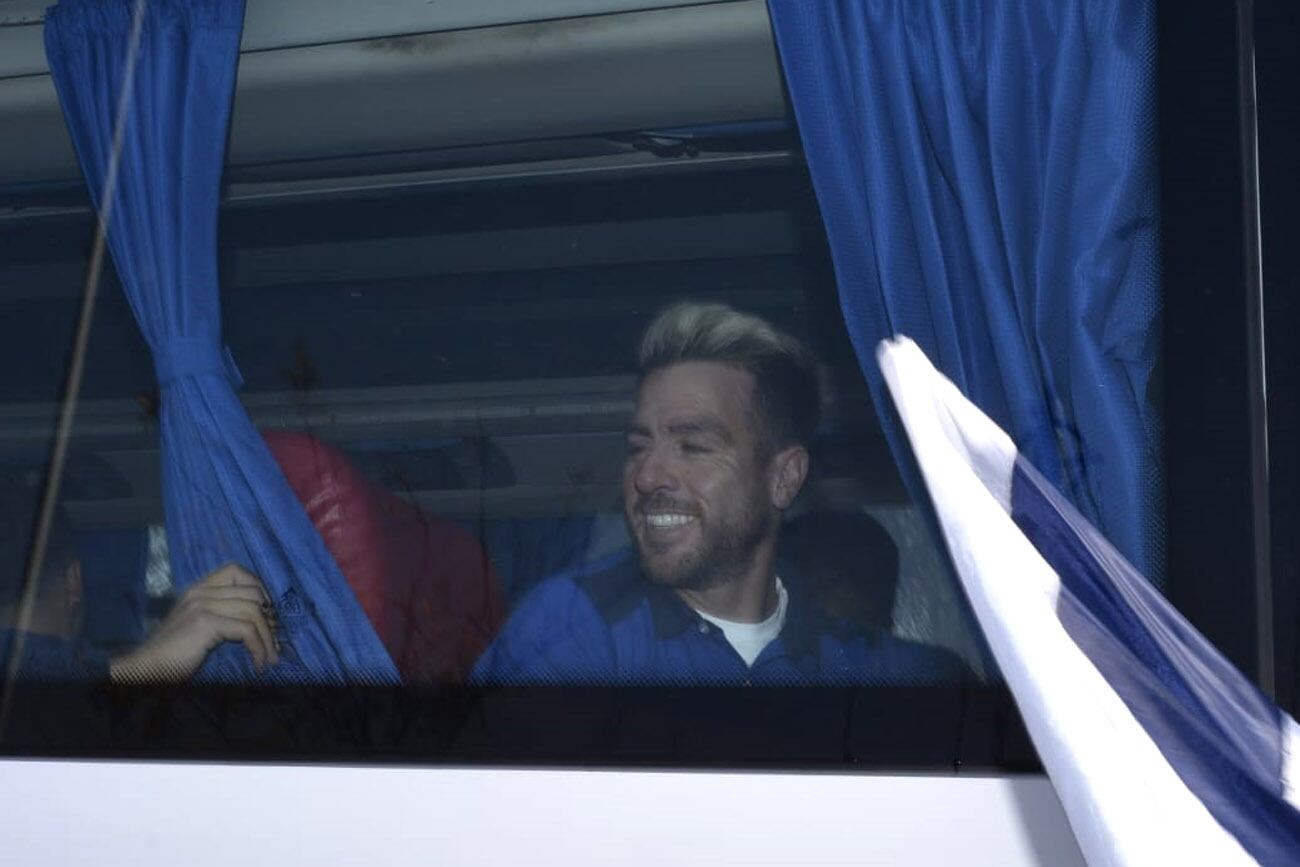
[472, 304, 962, 685]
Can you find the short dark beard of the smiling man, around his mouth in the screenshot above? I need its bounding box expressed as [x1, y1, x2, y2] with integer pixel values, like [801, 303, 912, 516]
[624, 498, 774, 593]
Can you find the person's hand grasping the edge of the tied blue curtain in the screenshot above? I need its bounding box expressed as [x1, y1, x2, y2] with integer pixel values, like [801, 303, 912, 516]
[109, 563, 280, 684]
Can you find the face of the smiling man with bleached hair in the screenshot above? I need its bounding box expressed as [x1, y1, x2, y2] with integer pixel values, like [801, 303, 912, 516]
[623, 361, 777, 590]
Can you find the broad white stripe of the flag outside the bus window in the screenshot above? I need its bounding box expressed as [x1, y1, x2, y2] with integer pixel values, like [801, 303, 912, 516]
[878, 338, 1255, 866]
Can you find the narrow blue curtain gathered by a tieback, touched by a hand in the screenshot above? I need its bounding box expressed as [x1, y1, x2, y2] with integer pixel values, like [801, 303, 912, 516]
[46, 0, 398, 682]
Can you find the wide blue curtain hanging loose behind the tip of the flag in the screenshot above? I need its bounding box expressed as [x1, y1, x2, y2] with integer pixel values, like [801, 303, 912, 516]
[770, 0, 1164, 580]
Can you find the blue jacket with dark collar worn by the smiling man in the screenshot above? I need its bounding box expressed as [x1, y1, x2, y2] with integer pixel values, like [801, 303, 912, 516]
[469, 556, 966, 686]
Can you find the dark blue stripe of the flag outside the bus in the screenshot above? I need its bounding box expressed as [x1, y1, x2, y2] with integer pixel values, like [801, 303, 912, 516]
[1011, 459, 1300, 864]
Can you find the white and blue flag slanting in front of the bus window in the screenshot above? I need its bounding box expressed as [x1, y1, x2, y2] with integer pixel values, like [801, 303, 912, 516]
[878, 338, 1300, 864]
